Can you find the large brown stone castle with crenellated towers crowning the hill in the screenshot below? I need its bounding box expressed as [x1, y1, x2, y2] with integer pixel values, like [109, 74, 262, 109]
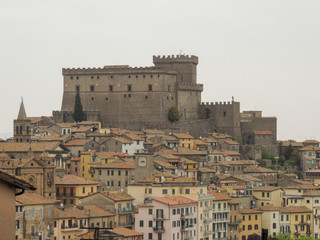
[53, 55, 276, 139]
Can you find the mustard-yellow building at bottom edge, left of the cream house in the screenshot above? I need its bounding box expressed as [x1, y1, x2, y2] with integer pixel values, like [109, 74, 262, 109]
[240, 208, 262, 240]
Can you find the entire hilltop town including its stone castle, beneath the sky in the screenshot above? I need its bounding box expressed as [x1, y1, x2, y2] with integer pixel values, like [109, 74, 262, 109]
[0, 56, 320, 240]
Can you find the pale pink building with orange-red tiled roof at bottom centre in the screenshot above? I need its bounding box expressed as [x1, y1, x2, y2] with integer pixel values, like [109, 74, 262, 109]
[135, 195, 198, 240]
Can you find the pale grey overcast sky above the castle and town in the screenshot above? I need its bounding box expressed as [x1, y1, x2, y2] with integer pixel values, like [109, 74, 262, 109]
[0, 0, 320, 141]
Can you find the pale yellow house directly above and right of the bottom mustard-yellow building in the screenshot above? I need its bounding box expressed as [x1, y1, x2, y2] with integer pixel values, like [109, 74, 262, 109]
[252, 186, 283, 207]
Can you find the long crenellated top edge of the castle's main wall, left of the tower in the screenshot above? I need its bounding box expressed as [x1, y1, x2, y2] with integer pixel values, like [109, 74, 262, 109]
[62, 65, 177, 75]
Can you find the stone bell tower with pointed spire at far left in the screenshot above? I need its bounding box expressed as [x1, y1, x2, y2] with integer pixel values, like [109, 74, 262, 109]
[13, 100, 31, 142]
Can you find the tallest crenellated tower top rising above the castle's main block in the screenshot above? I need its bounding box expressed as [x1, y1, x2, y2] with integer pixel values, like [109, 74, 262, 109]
[153, 55, 198, 83]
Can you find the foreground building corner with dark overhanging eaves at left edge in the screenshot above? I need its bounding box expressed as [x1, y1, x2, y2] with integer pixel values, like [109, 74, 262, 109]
[0, 170, 34, 239]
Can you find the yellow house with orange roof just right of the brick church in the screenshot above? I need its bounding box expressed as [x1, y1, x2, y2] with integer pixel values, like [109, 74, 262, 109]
[55, 175, 100, 205]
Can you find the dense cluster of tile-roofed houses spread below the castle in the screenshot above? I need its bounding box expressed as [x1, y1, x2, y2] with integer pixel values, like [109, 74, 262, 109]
[0, 103, 320, 240]
